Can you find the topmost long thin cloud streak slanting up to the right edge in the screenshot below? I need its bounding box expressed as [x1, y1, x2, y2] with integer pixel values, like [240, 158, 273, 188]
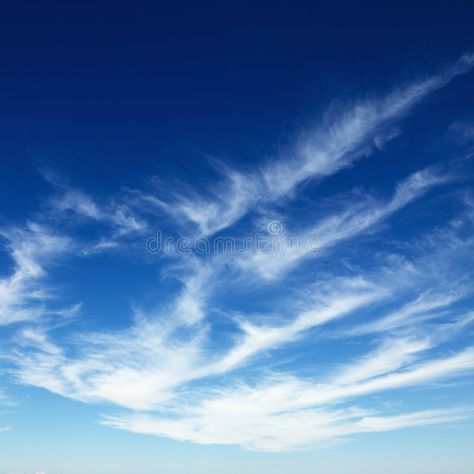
[142, 54, 474, 235]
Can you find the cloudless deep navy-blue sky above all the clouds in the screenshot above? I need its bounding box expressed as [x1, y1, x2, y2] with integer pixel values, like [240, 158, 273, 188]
[0, 1, 474, 212]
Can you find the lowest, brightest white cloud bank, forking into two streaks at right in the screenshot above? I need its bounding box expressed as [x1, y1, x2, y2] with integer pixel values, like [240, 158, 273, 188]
[103, 346, 474, 451]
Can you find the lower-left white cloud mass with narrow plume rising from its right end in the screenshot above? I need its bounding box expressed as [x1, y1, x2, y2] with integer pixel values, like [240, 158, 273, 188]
[12, 264, 209, 409]
